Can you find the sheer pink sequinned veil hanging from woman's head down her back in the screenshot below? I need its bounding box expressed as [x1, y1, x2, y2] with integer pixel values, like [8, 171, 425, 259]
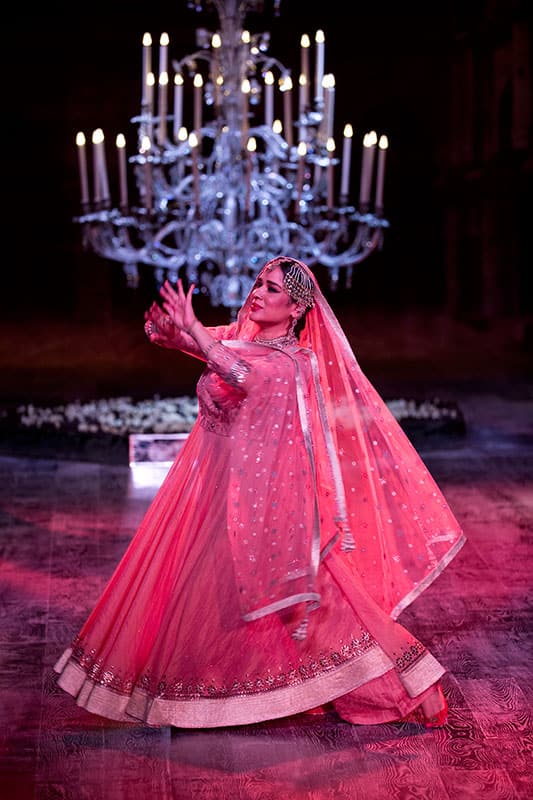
[231, 257, 465, 619]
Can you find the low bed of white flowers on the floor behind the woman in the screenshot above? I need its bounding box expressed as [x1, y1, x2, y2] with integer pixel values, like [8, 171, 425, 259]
[17, 395, 459, 436]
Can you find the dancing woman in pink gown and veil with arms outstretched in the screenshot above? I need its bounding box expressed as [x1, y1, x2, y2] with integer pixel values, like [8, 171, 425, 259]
[55, 257, 464, 728]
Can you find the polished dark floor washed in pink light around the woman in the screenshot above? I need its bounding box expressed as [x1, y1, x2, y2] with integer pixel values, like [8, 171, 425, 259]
[0, 381, 533, 800]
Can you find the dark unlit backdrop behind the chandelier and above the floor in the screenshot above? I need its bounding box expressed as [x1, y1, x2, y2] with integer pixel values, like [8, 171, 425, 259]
[0, 0, 532, 402]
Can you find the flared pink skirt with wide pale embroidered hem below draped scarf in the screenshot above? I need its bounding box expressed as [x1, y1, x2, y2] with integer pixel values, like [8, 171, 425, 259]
[54, 423, 454, 728]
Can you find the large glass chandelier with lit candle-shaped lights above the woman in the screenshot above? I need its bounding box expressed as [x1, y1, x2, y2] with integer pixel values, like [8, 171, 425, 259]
[75, 0, 389, 314]
